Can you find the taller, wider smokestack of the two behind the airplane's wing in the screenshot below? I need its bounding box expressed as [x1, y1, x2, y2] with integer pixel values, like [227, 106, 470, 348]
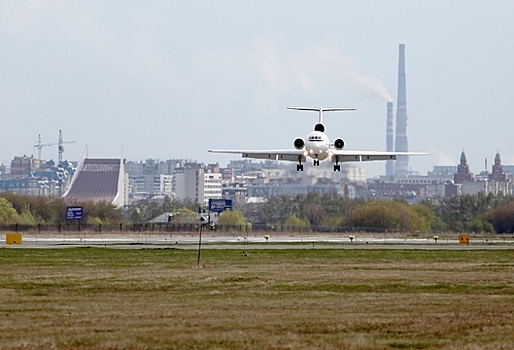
[395, 44, 409, 174]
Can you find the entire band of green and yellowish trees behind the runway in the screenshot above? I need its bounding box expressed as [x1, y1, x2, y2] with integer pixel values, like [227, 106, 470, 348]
[0, 192, 514, 233]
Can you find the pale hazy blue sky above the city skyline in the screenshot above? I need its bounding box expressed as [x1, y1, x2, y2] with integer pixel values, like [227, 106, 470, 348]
[0, 0, 514, 177]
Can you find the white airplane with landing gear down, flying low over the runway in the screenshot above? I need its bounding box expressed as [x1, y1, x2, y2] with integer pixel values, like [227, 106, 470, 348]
[209, 107, 427, 171]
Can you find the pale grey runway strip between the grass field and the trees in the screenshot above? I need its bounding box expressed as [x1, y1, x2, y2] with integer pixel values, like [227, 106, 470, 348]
[0, 232, 514, 250]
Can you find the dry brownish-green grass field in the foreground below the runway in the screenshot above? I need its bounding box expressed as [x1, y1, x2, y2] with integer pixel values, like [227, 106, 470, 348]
[0, 248, 514, 349]
